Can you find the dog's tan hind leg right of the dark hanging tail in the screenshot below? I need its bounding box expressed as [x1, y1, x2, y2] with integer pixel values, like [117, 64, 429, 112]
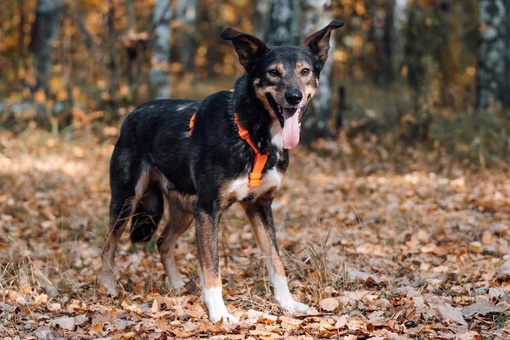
[157, 192, 193, 291]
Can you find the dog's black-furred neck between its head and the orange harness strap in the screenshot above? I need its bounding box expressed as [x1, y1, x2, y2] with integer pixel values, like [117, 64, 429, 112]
[232, 73, 282, 152]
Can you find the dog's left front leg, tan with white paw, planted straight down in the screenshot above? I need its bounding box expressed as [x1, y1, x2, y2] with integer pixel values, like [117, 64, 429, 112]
[195, 201, 238, 323]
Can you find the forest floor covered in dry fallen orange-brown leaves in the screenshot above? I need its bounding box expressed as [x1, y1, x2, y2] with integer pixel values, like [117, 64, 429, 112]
[0, 129, 510, 339]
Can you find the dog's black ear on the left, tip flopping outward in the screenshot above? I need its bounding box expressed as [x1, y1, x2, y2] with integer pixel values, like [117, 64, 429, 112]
[220, 28, 267, 71]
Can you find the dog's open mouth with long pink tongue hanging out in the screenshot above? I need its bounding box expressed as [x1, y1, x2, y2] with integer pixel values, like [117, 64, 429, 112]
[268, 96, 303, 149]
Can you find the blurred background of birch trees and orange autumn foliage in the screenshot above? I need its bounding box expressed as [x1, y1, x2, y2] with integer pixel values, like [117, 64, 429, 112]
[0, 0, 510, 165]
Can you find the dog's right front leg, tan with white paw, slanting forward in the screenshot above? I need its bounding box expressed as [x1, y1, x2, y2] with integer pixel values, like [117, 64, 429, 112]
[243, 198, 308, 313]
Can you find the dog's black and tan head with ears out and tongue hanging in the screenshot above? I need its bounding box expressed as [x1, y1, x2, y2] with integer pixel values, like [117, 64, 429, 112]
[221, 20, 344, 149]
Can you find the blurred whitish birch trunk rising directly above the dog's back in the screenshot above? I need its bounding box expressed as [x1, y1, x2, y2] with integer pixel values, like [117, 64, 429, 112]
[149, 0, 172, 98]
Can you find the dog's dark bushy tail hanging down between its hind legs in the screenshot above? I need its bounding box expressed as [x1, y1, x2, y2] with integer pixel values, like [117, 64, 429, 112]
[129, 183, 164, 242]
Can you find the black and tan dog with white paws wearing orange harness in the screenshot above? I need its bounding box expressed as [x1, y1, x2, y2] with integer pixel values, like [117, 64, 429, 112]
[100, 20, 343, 323]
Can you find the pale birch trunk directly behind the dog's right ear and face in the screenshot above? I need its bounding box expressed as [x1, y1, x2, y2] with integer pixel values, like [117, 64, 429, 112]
[300, 0, 341, 143]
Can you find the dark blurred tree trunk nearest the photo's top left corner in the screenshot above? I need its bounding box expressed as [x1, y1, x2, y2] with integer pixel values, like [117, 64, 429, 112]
[30, 0, 64, 92]
